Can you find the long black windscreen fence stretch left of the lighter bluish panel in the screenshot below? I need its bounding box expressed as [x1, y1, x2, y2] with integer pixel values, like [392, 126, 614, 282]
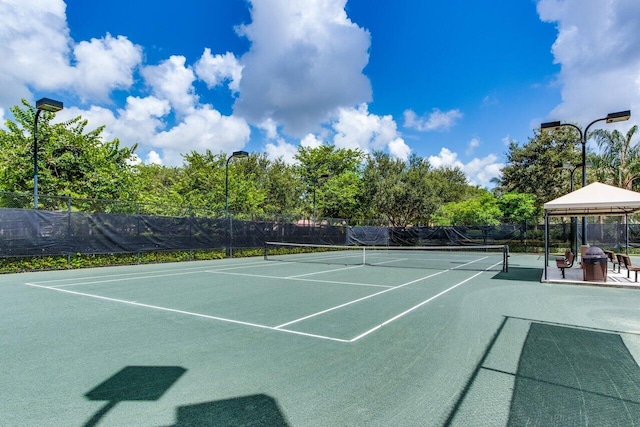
[0, 209, 346, 257]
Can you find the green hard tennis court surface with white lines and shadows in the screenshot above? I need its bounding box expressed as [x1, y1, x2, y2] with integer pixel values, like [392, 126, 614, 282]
[0, 254, 640, 426]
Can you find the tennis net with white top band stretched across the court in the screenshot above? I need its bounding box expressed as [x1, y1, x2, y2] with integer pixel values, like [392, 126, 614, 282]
[264, 242, 509, 272]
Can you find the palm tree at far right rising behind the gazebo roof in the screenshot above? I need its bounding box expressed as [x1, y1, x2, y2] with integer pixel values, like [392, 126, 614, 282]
[591, 125, 640, 190]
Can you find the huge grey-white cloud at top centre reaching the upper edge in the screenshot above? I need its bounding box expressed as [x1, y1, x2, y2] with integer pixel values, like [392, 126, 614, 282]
[234, 0, 372, 137]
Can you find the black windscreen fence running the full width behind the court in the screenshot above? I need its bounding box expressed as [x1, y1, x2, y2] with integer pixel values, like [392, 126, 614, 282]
[0, 208, 640, 257]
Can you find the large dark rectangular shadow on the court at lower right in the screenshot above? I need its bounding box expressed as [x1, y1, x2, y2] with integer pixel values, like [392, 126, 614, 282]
[508, 323, 640, 426]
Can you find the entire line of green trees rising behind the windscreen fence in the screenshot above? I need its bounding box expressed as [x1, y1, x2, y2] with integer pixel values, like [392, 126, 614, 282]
[0, 100, 640, 226]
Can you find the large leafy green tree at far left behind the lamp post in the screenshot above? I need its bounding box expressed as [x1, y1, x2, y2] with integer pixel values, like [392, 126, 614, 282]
[0, 100, 136, 207]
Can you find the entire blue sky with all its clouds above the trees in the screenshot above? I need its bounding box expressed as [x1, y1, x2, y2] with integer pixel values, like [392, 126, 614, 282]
[0, 0, 640, 187]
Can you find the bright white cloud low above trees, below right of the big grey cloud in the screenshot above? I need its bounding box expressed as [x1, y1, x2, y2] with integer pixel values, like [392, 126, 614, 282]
[333, 104, 411, 160]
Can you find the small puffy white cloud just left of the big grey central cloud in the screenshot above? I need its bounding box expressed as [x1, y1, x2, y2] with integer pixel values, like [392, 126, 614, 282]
[195, 48, 243, 93]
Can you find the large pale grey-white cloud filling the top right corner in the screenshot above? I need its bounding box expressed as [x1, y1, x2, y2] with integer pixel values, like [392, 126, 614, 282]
[537, 0, 640, 134]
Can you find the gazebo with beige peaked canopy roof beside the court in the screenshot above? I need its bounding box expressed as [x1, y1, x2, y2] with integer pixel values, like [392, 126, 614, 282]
[544, 182, 640, 280]
